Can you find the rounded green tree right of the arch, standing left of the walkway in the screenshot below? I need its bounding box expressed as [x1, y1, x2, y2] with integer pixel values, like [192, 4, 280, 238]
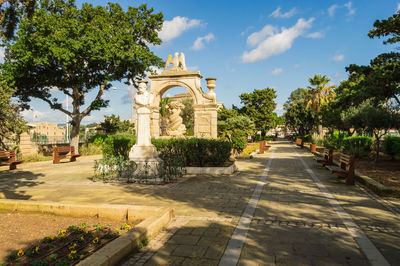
[239, 88, 276, 136]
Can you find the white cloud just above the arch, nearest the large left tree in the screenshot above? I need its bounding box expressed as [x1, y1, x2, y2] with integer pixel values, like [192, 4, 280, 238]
[158, 16, 202, 42]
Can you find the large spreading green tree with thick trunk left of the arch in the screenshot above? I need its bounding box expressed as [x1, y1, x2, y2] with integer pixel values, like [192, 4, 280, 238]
[2, 0, 163, 152]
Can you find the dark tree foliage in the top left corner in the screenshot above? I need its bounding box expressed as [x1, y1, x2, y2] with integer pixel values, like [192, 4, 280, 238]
[0, 0, 36, 41]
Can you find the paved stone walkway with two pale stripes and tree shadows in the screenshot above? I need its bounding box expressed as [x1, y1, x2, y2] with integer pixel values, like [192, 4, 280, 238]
[0, 141, 400, 265]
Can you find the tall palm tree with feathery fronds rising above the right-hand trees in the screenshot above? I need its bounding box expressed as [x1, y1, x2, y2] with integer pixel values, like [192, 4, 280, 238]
[306, 74, 336, 136]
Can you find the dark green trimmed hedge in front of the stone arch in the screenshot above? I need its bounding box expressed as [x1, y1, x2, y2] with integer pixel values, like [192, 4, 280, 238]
[152, 138, 232, 167]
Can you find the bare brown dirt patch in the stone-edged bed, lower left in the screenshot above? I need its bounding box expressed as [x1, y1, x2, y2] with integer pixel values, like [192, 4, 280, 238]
[0, 212, 140, 264]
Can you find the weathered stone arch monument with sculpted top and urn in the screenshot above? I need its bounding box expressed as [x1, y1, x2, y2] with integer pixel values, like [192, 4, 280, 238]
[149, 53, 218, 138]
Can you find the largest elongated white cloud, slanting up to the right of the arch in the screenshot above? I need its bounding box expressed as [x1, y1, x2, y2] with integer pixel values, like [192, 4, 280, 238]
[242, 18, 314, 63]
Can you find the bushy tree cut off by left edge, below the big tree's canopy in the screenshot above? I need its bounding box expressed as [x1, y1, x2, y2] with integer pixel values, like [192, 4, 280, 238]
[0, 76, 26, 149]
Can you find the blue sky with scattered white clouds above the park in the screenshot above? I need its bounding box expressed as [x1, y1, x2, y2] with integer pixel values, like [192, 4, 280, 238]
[13, 0, 400, 124]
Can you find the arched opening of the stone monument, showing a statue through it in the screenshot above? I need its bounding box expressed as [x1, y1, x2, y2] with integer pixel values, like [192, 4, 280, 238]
[159, 86, 194, 136]
